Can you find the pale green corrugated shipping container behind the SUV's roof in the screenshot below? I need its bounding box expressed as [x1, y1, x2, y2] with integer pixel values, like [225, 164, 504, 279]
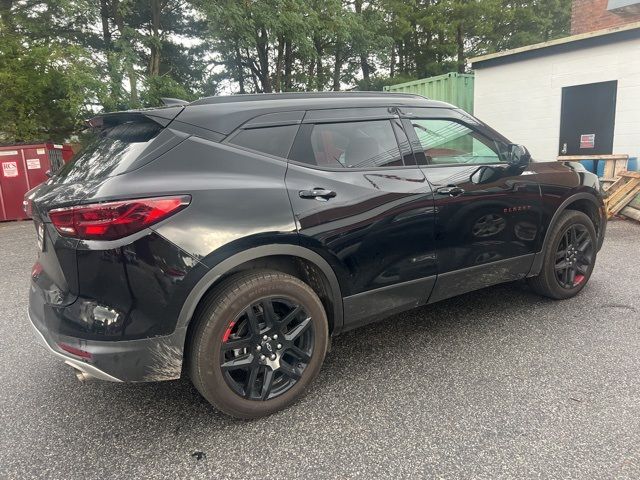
[384, 72, 473, 113]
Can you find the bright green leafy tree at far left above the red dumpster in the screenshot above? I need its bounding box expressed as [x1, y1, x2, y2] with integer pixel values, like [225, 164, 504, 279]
[0, 2, 102, 143]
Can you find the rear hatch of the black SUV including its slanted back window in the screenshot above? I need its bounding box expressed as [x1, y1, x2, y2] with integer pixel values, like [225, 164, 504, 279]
[30, 107, 185, 306]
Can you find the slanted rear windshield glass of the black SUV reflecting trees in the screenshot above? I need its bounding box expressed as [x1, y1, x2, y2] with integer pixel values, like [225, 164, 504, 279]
[54, 121, 162, 183]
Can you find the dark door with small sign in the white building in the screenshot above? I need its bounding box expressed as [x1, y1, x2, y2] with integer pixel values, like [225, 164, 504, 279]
[558, 81, 618, 155]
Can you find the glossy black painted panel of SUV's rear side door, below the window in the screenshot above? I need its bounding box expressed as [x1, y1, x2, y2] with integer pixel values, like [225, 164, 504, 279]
[287, 164, 436, 296]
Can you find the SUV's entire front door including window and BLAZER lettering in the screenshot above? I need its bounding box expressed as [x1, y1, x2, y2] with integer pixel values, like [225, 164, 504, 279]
[404, 108, 542, 302]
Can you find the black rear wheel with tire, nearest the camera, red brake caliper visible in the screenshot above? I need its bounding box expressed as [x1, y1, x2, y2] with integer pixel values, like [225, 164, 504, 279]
[190, 271, 328, 419]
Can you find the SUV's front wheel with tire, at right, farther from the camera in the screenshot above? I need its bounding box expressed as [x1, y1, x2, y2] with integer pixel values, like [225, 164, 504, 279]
[529, 210, 596, 299]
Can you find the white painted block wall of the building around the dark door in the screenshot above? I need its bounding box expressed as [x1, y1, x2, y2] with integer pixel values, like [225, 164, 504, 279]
[474, 39, 640, 160]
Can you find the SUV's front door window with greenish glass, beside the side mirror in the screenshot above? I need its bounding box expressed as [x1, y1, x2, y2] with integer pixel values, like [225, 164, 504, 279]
[411, 119, 506, 165]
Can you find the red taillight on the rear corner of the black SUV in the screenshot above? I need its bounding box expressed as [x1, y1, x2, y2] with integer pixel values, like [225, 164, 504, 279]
[49, 195, 191, 240]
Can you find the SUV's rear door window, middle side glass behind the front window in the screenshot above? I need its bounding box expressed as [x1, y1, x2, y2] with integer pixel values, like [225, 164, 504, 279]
[291, 120, 404, 168]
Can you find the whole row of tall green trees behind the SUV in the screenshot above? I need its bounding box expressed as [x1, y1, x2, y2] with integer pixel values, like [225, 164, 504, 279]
[0, 0, 570, 142]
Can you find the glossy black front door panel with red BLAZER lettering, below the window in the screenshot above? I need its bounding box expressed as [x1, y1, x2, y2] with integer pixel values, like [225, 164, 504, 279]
[424, 165, 541, 273]
